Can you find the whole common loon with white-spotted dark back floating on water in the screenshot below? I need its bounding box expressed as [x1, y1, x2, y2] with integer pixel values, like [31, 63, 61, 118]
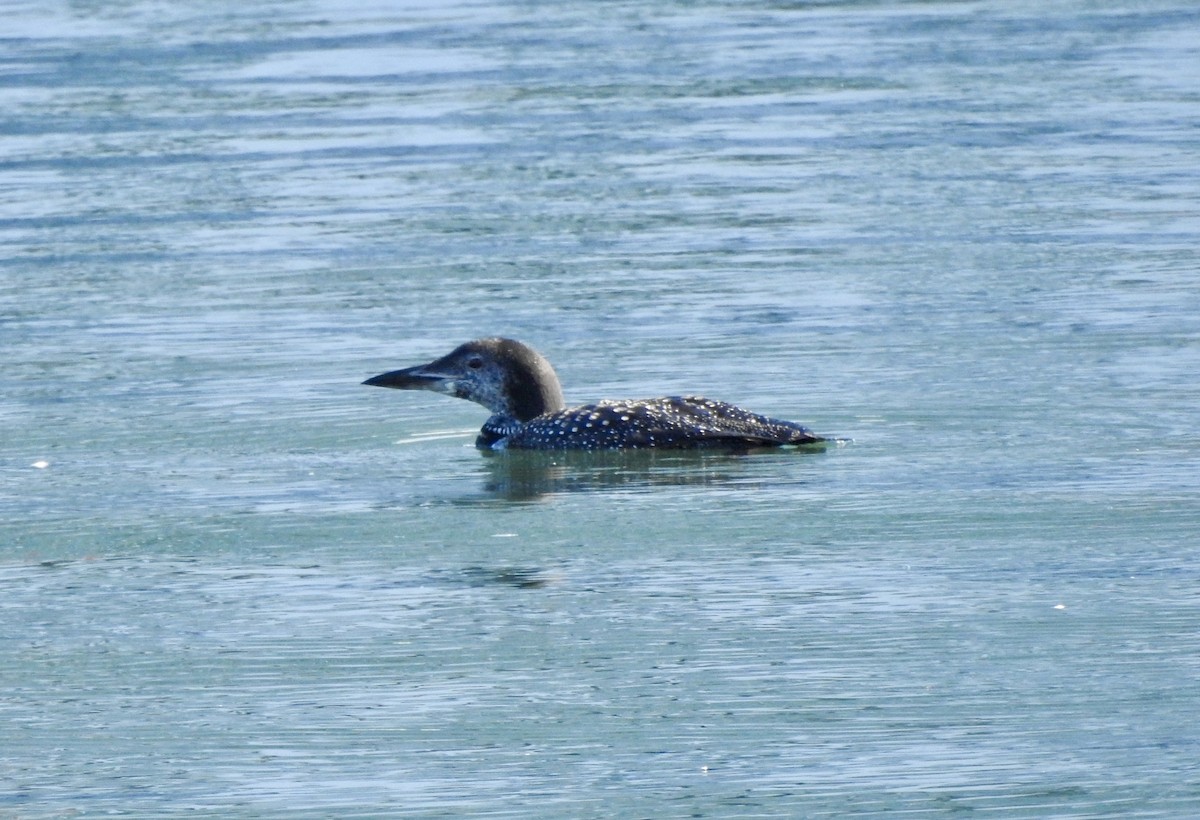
[364, 339, 824, 450]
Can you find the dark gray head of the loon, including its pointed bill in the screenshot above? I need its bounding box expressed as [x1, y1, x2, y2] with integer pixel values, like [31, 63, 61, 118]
[364, 339, 564, 421]
